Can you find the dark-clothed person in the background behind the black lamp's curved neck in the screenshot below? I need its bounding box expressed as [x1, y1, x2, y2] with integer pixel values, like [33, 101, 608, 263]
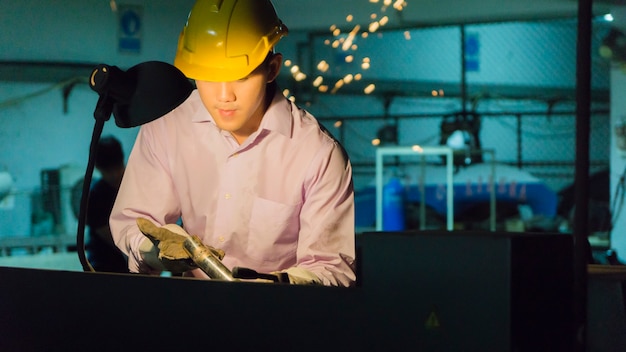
[86, 136, 128, 273]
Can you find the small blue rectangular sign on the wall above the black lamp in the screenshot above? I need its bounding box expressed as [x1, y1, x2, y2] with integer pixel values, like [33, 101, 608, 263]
[117, 5, 142, 54]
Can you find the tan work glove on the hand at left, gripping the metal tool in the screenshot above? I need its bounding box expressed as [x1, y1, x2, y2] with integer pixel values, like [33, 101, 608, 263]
[137, 218, 206, 274]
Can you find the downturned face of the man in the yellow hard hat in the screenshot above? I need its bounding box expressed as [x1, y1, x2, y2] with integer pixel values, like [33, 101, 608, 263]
[196, 54, 282, 144]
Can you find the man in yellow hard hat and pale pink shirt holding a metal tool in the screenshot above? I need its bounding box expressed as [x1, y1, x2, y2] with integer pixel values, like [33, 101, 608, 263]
[110, 0, 356, 286]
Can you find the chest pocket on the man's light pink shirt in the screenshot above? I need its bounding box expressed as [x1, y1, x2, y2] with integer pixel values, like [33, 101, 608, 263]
[247, 198, 301, 262]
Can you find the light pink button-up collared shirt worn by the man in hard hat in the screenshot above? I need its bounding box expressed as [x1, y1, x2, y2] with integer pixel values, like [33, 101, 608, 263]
[110, 91, 355, 286]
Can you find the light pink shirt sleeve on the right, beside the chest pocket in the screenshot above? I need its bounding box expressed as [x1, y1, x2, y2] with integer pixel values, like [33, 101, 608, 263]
[297, 141, 356, 286]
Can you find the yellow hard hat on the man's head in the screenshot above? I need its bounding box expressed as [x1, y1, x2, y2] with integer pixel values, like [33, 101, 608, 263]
[174, 0, 288, 82]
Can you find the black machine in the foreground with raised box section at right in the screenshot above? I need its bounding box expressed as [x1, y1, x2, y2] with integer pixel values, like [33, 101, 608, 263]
[0, 231, 574, 352]
